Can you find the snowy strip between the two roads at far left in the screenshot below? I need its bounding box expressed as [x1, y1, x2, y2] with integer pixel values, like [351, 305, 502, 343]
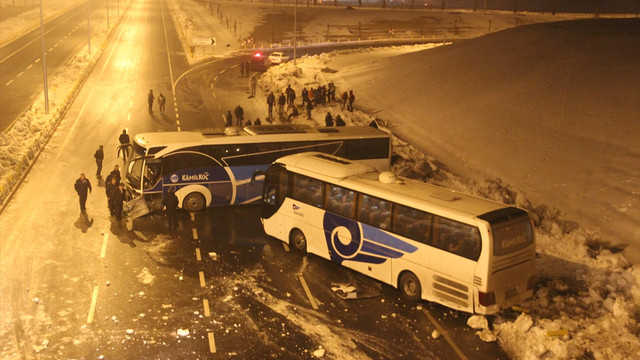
[0, 1, 130, 203]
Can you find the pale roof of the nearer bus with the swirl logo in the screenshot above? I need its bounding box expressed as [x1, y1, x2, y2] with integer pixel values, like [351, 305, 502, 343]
[276, 152, 511, 218]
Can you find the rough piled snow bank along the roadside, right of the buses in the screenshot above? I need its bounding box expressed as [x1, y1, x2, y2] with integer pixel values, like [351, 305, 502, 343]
[259, 40, 640, 359]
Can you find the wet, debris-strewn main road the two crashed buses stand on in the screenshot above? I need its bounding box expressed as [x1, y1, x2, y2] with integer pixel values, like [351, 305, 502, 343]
[0, 0, 506, 359]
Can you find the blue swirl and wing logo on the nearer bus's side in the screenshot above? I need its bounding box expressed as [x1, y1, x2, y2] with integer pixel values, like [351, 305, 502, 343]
[323, 212, 418, 264]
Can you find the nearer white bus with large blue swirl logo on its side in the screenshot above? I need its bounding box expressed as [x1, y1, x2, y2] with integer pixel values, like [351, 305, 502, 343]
[261, 152, 535, 314]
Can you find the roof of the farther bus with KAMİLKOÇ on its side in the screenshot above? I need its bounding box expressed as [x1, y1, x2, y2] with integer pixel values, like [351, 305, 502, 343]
[134, 124, 389, 152]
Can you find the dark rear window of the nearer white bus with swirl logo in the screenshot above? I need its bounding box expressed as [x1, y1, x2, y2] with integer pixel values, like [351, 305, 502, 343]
[491, 217, 533, 256]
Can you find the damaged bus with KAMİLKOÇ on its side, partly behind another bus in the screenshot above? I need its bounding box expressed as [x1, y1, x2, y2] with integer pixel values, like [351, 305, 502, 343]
[125, 125, 391, 215]
